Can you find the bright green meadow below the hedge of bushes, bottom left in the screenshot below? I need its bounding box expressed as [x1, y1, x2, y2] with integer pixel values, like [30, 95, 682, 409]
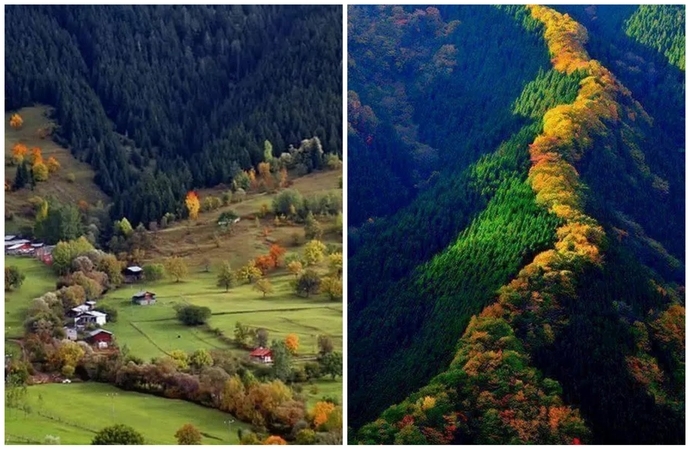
[5, 383, 243, 445]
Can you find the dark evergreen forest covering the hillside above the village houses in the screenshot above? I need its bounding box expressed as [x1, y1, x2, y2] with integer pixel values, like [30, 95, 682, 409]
[5, 5, 342, 232]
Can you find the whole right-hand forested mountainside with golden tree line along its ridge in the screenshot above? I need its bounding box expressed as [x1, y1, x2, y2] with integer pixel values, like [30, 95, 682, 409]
[348, 6, 685, 444]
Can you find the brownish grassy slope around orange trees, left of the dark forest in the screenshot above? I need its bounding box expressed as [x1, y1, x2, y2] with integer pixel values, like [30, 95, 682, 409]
[5, 106, 108, 232]
